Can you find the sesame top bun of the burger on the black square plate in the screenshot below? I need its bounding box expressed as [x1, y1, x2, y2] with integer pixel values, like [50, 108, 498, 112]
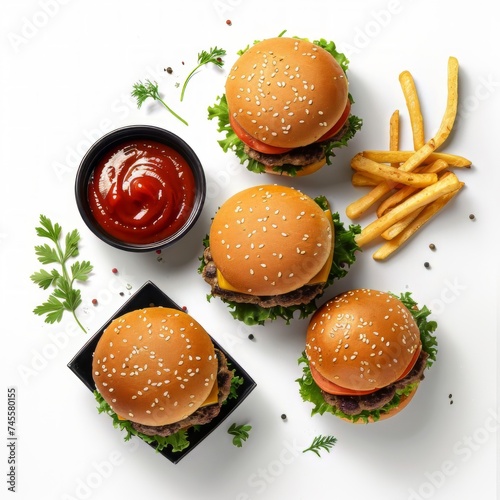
[92, 307, 217, 426]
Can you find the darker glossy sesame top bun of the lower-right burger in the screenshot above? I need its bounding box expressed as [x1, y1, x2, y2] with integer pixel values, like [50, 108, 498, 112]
[306, 289, 421, 391]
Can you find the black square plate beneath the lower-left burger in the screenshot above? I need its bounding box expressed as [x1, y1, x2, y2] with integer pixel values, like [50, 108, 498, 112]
[68, 281, 257, 463]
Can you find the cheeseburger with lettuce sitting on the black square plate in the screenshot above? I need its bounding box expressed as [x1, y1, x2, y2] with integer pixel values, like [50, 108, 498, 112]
[92, 307, 242, 452]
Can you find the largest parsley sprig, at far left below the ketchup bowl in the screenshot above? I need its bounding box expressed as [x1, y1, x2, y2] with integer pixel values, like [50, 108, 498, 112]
[30, 215, 93, 333]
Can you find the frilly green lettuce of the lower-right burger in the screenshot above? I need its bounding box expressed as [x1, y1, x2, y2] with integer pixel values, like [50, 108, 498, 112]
[296, 292, 437, 422]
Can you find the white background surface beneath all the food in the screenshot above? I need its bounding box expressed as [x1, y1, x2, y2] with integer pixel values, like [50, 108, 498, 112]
[0, 0, 500, 500]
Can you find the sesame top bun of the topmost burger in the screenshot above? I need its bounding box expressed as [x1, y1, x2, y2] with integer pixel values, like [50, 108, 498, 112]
[226, 37, 348, 148]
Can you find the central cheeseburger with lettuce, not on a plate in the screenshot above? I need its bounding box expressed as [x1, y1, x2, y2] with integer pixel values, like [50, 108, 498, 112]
[199, 185, 359, 325]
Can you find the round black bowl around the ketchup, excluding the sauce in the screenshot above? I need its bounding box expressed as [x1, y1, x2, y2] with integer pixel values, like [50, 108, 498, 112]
[75, 125, 206, 252]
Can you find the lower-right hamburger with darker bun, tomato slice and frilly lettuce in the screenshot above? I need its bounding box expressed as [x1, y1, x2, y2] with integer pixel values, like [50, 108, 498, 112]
[297, 289, 437, 423]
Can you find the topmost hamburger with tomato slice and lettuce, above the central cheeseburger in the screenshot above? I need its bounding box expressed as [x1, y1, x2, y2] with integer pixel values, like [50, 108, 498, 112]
[208, 36, 362, 175]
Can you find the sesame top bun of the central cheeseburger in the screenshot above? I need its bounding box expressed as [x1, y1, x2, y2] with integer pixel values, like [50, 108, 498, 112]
[209, 185, 333, 295]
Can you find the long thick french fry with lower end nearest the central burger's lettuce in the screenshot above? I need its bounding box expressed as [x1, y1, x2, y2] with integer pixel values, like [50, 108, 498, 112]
[356, 172, 460, 247]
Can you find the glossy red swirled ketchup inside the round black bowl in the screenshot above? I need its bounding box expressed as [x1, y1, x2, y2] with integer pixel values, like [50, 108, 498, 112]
[88, 139, 195, 244]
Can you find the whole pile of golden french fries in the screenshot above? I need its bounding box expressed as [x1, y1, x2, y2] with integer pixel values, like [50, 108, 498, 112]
[346, 57, 471, 260]
